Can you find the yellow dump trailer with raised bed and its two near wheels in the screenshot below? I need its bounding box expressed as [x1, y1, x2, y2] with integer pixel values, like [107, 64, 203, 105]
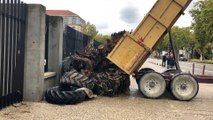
[107, 0, 199, 100]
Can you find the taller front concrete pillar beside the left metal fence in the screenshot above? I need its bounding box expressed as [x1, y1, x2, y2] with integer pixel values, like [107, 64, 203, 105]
[23, 4, 46, 101]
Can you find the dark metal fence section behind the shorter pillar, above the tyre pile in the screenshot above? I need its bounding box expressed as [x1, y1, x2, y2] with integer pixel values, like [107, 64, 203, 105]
[63, 25, 91, 58]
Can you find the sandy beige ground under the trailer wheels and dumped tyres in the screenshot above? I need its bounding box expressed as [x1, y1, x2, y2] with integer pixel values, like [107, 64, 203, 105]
[0, 59, 213, 120]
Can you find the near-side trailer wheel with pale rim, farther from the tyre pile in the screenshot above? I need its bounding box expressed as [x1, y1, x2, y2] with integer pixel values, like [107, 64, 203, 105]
[170, 73, 199, 101]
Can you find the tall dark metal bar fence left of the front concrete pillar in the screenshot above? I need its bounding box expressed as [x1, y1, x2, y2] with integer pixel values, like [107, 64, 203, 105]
[0, 0, 27, 109]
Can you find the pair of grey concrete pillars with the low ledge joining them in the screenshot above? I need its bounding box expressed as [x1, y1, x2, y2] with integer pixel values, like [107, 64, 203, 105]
[24, 4, 63, 101]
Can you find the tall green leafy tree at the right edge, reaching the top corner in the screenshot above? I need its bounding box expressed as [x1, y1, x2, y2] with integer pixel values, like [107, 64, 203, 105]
[190, 0, 213, 60]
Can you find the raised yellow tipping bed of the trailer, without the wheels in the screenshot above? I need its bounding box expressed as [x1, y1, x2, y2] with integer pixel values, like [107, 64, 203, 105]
[107, 0, 192, 74]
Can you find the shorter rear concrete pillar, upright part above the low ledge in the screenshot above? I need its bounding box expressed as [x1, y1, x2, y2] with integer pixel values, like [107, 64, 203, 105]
[48, 16, 63, 80]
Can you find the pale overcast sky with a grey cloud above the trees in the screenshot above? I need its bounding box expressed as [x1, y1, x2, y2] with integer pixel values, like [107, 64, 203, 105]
[22, 0, 197, 34]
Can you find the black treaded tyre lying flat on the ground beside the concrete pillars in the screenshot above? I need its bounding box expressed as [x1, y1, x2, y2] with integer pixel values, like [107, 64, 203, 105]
[45, 86, 86, 104]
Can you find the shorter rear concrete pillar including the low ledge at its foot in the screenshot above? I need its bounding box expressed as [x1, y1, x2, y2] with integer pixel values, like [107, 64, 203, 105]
[43, 16, 63, 92]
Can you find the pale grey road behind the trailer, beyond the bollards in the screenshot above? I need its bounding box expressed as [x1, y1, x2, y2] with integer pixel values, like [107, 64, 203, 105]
[147, 58, 213, 75]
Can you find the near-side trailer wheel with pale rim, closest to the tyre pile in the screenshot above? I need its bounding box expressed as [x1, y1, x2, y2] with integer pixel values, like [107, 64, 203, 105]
[138, 72, 166, 98]
